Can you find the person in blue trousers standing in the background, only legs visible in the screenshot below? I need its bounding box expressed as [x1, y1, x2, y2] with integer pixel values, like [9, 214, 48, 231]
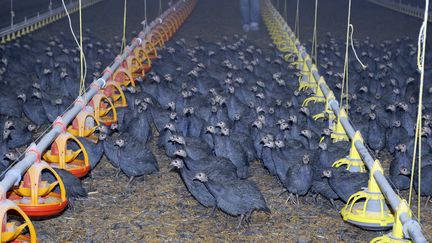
[240, 0, 260, 32]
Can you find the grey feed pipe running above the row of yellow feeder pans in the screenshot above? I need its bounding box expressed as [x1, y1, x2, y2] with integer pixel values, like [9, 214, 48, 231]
[270, 0, 428, 243]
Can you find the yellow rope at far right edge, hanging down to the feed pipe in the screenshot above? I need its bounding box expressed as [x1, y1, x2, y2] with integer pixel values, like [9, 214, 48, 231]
[408, 0, 429, 223]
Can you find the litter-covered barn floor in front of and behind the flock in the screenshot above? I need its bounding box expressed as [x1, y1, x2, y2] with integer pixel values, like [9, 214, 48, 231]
[3, 0, 432, 242]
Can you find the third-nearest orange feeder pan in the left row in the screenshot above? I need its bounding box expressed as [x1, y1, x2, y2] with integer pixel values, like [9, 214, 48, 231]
[43, 132, 91, 178]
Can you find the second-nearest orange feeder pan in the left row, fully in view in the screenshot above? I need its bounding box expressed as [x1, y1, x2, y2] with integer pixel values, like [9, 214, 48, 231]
[8, 161, 68, 217]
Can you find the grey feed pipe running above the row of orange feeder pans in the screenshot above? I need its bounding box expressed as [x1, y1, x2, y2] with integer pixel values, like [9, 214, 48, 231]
[0, 0, 190, 198]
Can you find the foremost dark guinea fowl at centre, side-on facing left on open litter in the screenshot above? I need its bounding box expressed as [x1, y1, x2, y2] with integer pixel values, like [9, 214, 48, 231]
[194, 173, 271, 229]
